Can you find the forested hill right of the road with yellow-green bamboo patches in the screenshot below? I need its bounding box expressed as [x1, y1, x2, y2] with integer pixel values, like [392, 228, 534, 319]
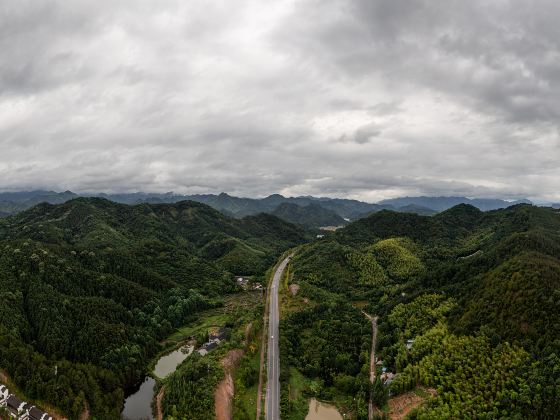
[286, 204, 560, 418]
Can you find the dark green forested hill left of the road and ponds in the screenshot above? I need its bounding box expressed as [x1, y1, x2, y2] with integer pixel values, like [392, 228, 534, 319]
[0, 198, 306, 419]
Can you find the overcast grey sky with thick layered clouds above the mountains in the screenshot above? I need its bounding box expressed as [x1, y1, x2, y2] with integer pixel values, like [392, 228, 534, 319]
[0, 0, 560, 201]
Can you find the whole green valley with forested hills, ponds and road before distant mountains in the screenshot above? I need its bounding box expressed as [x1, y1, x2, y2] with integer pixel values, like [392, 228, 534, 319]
[0, 198, 560, 420]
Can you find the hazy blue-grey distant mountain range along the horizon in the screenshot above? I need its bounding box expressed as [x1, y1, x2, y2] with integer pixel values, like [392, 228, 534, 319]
[0, 190, 531, 228]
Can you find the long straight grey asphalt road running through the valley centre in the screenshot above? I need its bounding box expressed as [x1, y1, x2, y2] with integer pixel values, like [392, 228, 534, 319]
[266, 256, 291, 420]
